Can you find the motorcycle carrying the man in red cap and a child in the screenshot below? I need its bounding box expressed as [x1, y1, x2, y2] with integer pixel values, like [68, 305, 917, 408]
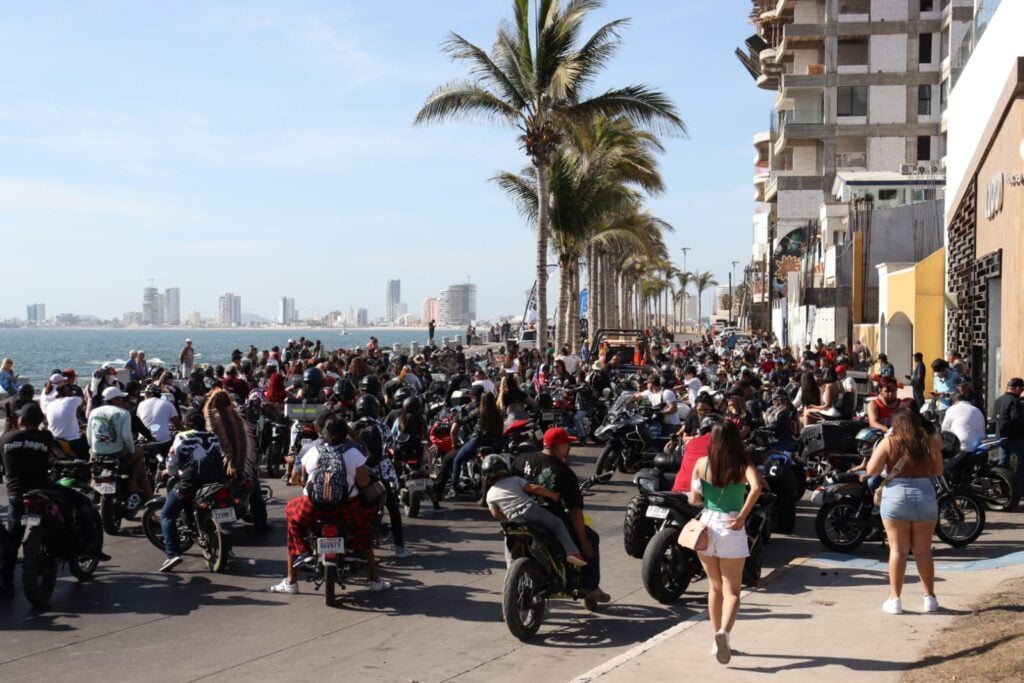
[502, 477, 607, 642]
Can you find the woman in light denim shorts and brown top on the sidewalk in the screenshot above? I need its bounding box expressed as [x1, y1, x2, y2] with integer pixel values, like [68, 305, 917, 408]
[867, 407, 942, 614]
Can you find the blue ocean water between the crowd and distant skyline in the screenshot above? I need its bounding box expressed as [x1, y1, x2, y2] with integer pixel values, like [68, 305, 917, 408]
[0, 328, 462, 388]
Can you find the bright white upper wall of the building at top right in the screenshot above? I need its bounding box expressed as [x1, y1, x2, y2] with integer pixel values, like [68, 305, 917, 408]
[946, 0, 1024, 222]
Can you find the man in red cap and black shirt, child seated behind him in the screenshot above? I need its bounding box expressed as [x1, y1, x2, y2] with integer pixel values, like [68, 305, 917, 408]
[512, 427, 611, 602]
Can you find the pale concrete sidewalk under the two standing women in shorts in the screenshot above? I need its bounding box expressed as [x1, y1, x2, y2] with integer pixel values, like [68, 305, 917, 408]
[574, 558, 1024, 683]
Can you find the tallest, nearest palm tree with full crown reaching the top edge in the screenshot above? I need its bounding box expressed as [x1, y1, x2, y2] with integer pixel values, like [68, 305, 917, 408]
[416, 0, 686, 348]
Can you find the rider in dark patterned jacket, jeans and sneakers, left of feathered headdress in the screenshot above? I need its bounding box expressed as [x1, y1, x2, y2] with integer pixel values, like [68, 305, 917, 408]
[160, 409, 226, 573]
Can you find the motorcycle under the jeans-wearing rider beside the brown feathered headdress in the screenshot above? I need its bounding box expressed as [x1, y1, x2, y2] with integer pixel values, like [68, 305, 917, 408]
[142, 480, 235, 572]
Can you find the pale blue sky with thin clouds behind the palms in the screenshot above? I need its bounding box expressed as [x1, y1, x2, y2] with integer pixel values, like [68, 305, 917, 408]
[0, 0, 770, 318]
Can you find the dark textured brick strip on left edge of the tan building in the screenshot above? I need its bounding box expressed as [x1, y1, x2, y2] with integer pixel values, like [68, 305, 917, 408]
[946, 177, 978, 357]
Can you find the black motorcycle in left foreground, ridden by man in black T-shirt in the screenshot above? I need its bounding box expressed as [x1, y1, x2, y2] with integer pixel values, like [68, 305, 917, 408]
[22, 461, 103, 607]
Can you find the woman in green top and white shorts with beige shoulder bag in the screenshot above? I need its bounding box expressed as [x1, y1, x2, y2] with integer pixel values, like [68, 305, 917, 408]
[690, 421, 761, 664]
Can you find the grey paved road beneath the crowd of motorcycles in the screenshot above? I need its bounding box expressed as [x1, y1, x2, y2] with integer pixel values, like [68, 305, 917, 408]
[0, 449, 1019, 682]
